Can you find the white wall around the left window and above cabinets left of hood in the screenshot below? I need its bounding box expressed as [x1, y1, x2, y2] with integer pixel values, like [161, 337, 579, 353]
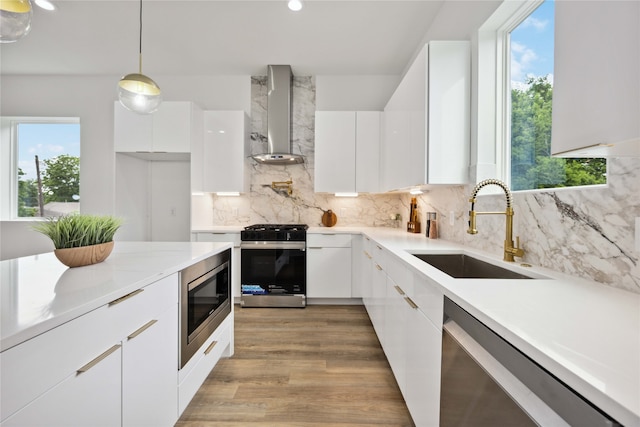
[0, 75, 251, 259]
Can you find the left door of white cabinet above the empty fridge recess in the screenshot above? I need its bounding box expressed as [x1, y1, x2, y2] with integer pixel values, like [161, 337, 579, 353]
[113, 101, 153, 153]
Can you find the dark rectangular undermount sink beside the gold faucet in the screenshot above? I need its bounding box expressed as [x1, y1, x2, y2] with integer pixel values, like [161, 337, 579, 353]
[413, 254, 533, 279]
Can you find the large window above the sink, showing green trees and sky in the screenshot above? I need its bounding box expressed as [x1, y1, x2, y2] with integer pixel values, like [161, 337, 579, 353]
[503, 0, 606, 191]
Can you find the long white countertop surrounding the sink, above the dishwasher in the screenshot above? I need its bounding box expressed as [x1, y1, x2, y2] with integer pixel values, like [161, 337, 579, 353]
[358, 228, 640, 426]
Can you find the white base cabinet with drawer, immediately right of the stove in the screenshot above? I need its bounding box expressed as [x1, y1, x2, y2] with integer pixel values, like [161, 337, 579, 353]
[307, 234, 351, 298]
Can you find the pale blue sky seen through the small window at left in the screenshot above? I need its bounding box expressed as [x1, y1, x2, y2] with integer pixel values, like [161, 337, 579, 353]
[18, 123, 80, 181]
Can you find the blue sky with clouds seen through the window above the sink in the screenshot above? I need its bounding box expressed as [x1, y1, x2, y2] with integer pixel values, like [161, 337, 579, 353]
[511, 0, 554, 88]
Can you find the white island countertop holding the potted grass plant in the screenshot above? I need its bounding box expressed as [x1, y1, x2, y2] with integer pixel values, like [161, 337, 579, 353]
[0, 242, 232, 351]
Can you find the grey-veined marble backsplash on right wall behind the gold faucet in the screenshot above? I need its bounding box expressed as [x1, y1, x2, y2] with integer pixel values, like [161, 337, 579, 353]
[410, 158, 640, 293]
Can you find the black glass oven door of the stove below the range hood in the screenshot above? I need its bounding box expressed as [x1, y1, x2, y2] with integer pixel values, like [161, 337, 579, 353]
[240, 242, 307, 295]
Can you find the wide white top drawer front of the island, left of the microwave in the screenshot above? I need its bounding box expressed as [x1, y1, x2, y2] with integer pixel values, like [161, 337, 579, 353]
[0, 274, 178, 419]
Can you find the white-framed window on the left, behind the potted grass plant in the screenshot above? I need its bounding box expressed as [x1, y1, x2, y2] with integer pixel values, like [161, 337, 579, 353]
[2, 117, 80, 219]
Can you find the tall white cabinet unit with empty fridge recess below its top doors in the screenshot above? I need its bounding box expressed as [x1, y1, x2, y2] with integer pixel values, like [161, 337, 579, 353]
[114, 102, 203, 241]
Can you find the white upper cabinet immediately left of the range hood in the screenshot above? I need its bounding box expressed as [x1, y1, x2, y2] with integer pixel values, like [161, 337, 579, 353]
[198, 111, 250, 193]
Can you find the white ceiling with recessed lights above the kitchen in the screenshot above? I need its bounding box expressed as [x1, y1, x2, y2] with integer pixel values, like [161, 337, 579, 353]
[0, 0, 499, 76]
